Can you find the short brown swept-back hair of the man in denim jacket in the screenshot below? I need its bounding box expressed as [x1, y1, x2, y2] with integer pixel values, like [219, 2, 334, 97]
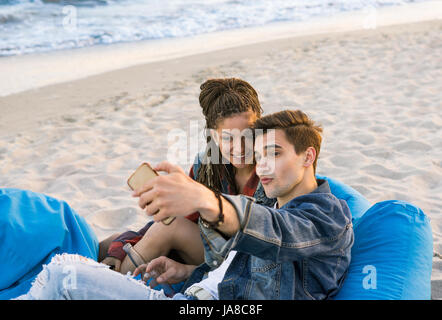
[254, 110, 322, 172]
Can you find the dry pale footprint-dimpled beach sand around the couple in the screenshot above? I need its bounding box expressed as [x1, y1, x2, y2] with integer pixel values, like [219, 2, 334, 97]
[0, 13, 442, 299]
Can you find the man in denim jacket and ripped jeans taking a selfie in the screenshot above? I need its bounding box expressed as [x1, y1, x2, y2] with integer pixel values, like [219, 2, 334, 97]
[19, 111, 353, 299]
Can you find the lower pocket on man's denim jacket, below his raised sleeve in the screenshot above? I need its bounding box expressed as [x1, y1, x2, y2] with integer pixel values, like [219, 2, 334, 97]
[249, 257, 282, 300]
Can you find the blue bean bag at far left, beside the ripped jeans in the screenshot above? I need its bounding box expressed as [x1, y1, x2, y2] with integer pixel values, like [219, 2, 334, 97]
[0, 189, 98, 300]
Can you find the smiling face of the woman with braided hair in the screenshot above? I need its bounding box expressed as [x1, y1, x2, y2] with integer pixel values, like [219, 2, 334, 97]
[215, 111, 258, 168]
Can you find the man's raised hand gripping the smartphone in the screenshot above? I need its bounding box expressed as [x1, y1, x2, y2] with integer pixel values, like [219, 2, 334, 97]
[133, 161, 216, 221]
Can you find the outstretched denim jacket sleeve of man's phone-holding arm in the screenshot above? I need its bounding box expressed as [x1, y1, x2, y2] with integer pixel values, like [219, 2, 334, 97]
[200, 194, 352, 267]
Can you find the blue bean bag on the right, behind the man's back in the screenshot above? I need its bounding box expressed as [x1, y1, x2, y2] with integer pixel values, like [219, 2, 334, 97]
[317, 175, 433, 300]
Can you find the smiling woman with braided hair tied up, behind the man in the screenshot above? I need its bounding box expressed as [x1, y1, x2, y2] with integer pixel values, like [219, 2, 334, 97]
[99, 78, 275, 274]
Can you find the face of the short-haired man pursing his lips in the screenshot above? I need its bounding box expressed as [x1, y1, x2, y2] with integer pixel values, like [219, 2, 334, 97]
[254, 129, 305, 198]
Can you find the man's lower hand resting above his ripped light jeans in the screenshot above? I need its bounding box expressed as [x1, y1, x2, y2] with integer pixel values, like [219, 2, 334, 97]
[133, 256, 196, 288]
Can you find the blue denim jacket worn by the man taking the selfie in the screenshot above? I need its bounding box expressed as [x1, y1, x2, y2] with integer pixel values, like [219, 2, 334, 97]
[182, 180, 354, 300]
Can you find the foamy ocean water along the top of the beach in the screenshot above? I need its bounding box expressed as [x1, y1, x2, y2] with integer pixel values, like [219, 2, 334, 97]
[0, 0, 432, 56]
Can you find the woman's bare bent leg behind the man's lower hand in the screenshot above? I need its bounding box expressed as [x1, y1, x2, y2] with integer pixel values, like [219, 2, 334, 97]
[120, 218, 204, 274]
